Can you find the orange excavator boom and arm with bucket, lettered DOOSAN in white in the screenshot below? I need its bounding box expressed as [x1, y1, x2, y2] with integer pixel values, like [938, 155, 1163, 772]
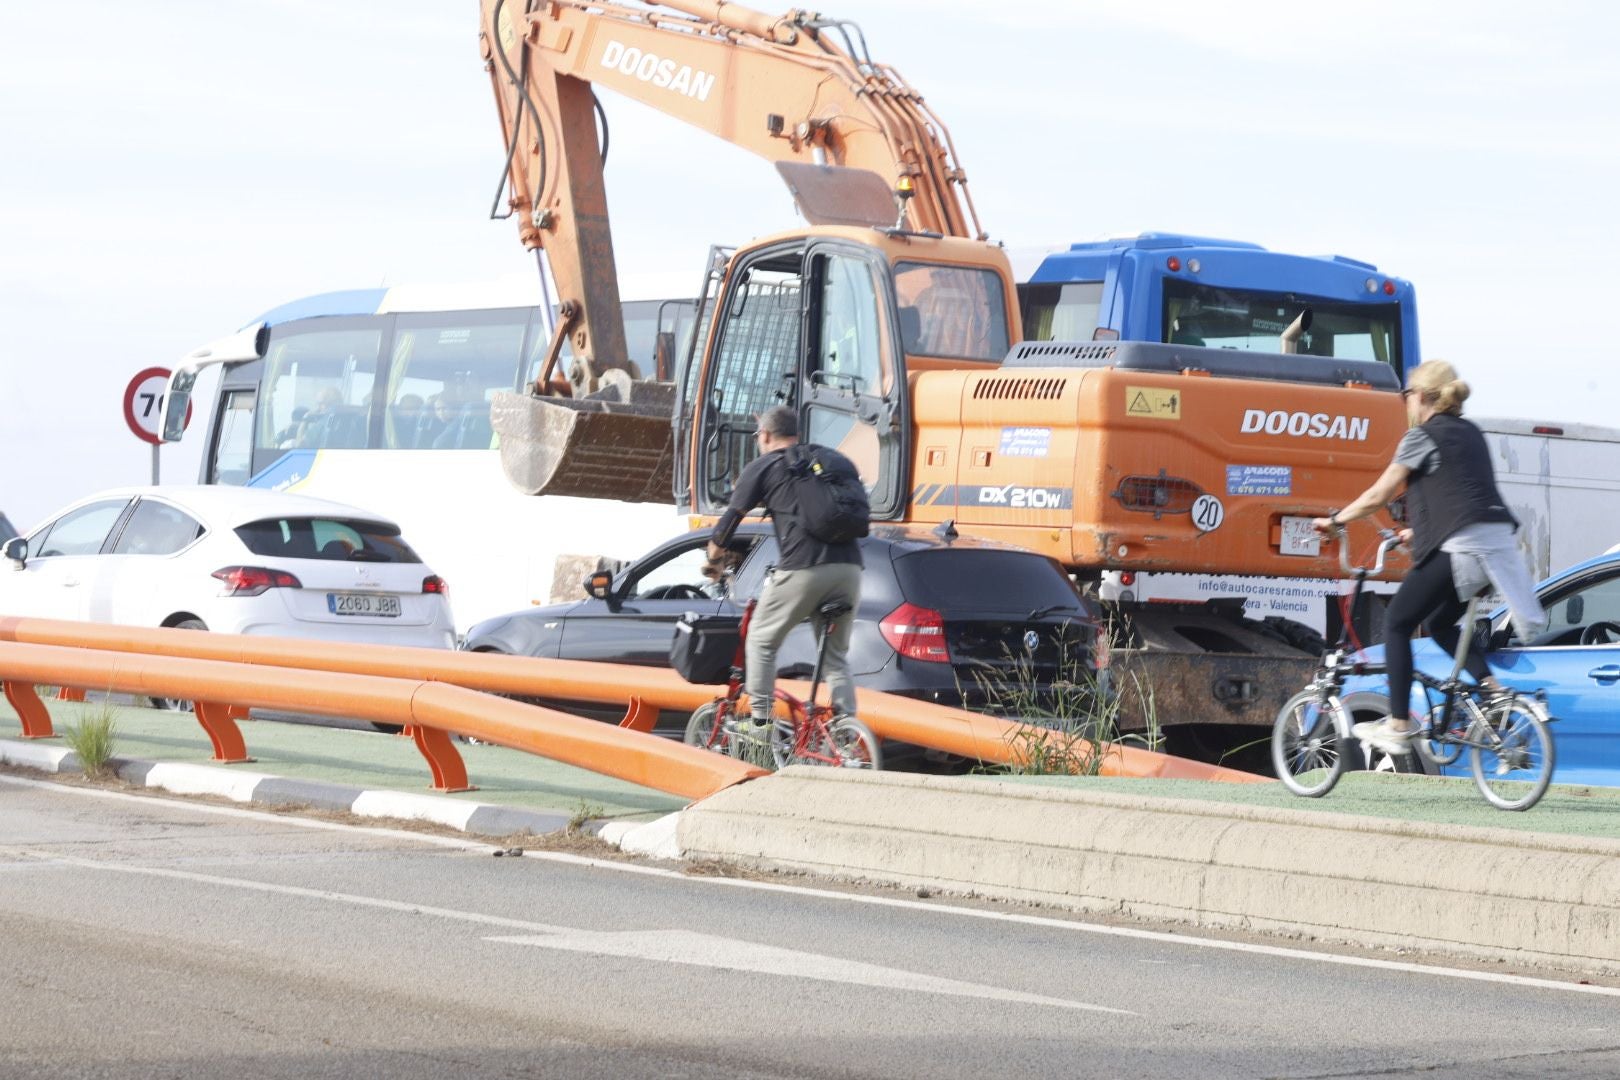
[481, 0, 985, 500]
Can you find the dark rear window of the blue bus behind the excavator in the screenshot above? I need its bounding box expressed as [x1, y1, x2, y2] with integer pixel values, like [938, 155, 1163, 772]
[1162, 279, 1401, 369]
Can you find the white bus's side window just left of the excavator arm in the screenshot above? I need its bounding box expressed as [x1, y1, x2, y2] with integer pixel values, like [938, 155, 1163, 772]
[382, 309, 530, 450]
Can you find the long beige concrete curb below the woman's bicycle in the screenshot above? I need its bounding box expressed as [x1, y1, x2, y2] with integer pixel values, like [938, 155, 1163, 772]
[677, 767, 1620, 973]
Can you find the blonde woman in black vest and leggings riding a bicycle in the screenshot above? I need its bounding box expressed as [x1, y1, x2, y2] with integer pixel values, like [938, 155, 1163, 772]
[1314, 359, 1547, 755]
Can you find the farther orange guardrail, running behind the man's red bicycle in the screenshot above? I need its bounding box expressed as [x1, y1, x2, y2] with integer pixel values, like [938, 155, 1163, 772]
[0, 617, 1264, 782]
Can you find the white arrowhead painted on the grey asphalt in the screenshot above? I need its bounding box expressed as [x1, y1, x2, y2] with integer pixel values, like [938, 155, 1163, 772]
[484, 929, 1140, 1017]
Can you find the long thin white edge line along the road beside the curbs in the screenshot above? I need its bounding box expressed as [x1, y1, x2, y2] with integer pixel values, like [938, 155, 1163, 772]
[9, 776, 1620, 997]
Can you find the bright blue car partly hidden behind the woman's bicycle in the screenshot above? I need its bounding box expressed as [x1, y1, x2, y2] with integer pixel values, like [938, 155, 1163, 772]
[1343, 547, 1620, 787]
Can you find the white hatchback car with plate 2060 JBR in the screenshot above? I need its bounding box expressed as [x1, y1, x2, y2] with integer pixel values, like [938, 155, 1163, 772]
[0, 486, 455, 649]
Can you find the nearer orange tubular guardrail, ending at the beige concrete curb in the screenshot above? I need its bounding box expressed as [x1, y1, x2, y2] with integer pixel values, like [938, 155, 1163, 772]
[0, 641, 765, 798]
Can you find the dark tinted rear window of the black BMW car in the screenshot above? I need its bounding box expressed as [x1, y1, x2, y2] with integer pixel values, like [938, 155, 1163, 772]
[894, 547, 1087, 614]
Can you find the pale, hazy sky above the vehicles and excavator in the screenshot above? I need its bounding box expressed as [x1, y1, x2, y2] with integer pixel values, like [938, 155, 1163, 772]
[0, 0, 1620, 526]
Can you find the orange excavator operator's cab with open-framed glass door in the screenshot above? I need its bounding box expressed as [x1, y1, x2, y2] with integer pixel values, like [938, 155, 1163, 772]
[690, 227, 1009, 520]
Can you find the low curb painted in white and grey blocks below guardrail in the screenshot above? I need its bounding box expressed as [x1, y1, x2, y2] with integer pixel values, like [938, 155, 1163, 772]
[0, 740, 569, 836]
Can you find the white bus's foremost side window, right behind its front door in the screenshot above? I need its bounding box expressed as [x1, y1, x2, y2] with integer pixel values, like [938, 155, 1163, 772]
[254, 329, 382, 450]
